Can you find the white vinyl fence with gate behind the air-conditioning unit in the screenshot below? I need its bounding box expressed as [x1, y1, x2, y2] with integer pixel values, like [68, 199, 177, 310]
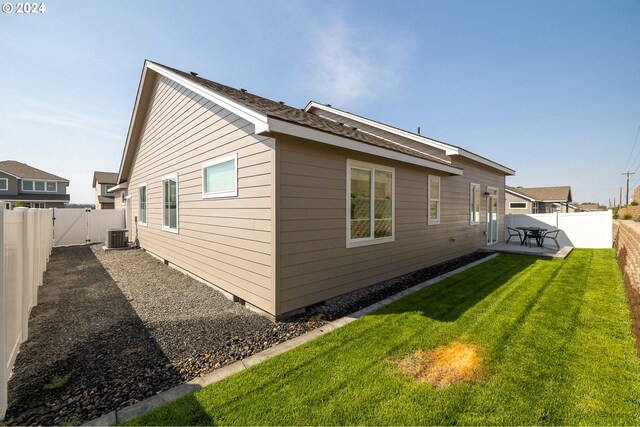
[53, 209, 125, 246]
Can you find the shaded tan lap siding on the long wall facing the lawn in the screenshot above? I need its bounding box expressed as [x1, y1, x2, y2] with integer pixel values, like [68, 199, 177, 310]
[277, 136, 504, 313]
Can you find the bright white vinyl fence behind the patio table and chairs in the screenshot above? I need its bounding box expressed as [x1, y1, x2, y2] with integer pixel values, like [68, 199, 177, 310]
[504, 211, 613, 249]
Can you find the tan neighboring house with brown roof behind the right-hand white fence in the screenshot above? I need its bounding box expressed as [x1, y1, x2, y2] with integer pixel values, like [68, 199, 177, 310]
[505, 186, 575, 214]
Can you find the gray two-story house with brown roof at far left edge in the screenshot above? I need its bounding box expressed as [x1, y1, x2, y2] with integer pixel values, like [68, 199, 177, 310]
[0, 160, 69, 208]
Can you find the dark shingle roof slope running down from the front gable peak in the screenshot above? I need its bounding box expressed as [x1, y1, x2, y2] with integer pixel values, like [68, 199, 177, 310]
[149, 61, 451, 166]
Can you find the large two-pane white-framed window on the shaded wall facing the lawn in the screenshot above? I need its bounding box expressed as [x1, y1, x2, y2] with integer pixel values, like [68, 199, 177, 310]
[347, 160, 394, 247]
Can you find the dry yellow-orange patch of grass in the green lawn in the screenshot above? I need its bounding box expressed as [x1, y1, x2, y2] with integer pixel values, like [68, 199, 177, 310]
[394, 341, 483, 388]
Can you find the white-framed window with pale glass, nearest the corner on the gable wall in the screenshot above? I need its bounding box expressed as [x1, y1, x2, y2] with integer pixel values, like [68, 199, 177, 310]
[202, 153, 238, 198]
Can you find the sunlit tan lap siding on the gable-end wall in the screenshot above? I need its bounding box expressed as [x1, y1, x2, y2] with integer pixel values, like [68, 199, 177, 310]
[129, 78, 275, 314]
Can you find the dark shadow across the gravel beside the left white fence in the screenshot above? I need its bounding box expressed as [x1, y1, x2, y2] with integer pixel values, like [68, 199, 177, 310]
[6, 246, 181, 425]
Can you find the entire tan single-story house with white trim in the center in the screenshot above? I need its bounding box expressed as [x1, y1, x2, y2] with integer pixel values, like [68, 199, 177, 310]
[111, 61, 515, 318]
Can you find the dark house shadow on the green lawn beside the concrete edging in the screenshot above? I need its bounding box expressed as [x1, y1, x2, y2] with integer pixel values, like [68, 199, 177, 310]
[373, 255, 549, 322]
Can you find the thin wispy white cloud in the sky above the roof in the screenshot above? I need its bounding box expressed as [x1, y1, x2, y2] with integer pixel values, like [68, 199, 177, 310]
[308, 20, 418, 105]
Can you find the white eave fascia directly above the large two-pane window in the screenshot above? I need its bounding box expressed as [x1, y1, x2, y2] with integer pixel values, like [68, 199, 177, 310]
[269, 117, 462, 175]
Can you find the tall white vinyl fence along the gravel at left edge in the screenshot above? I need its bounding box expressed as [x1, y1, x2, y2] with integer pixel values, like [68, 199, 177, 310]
[0, 208, 53, 420]
